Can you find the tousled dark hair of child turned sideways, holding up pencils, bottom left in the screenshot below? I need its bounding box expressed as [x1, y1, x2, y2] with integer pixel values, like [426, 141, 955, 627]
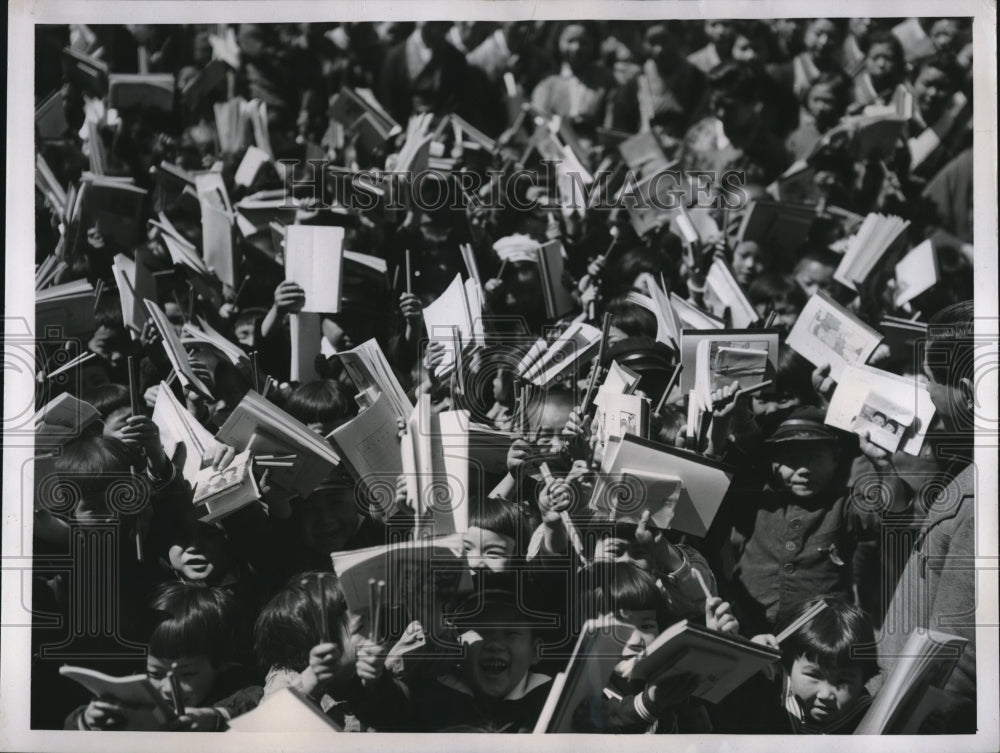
[253, 572, 354, 672]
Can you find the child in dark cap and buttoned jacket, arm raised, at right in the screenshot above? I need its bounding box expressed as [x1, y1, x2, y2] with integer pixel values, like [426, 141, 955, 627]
[723, 408, 912, 633]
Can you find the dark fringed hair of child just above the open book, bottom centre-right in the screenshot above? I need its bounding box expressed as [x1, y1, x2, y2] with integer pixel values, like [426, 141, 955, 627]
[584, 561, 678, 631]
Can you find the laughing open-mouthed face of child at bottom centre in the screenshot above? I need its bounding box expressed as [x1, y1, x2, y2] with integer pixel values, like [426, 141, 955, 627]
[464, 610, 541, 698]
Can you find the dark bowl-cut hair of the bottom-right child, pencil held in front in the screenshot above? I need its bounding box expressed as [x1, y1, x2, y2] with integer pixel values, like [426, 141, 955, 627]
[775, 597, 879, 681]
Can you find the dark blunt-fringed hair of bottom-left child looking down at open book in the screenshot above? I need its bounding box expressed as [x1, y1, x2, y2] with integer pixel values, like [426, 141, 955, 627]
[149, 583, 242, 668]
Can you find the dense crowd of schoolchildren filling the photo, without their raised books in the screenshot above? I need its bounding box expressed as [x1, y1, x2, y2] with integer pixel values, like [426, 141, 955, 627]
[31, 18, 977, 734]
